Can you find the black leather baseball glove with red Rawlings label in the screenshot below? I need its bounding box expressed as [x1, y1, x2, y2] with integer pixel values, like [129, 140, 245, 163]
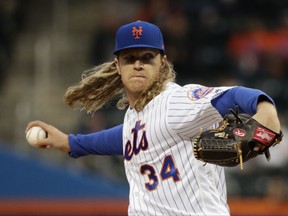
[194, 107, 283, 169]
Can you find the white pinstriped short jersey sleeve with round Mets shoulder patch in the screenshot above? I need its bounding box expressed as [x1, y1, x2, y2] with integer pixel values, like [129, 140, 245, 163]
[163, 84, 232, 140]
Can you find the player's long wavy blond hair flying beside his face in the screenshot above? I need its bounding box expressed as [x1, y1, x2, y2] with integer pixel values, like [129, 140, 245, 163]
[64, 61, 175, 113]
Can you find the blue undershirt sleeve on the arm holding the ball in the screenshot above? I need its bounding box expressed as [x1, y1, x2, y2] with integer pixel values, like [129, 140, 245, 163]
[68, 124, 123, 158]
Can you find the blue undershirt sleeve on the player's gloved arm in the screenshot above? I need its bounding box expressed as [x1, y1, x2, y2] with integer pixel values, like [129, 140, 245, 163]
[211, 86, 275, 117]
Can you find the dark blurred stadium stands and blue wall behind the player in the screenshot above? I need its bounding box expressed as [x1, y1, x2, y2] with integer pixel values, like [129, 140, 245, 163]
[0, 0, 288, 215]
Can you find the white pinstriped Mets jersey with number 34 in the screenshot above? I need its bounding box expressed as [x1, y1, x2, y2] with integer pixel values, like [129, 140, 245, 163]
[123, 83, 233, 216]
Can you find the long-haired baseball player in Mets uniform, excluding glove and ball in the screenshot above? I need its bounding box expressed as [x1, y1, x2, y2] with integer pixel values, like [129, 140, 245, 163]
[27, 21, 281, 215]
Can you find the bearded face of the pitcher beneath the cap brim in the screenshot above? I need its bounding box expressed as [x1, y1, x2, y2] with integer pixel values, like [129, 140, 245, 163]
[115, 48, 166, 101]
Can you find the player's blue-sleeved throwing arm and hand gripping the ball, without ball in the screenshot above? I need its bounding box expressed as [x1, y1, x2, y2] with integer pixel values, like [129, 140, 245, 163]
[26, 121, 123, 158]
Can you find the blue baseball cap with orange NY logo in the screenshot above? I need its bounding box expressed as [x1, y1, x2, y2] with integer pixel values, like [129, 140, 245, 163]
[113, 21, 165, 55]
